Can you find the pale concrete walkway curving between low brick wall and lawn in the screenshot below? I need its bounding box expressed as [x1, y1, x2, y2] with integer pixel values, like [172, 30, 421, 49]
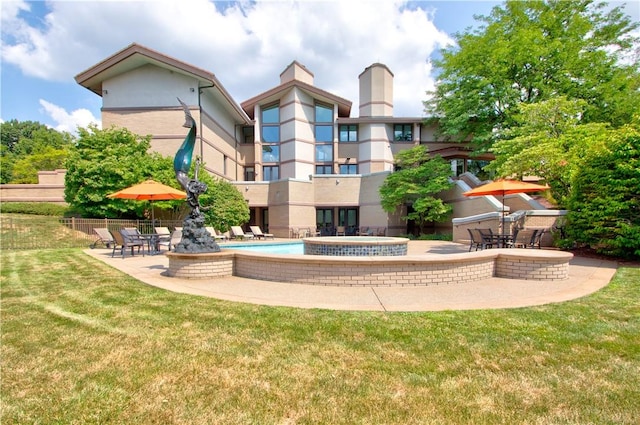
[85, 241, 617, 311]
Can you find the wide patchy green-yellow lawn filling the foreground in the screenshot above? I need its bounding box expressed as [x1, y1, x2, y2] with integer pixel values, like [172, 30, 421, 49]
[0, 249, 640, 425]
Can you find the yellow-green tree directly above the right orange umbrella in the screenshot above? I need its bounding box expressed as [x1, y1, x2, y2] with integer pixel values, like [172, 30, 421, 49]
[485, 97, 611, 207]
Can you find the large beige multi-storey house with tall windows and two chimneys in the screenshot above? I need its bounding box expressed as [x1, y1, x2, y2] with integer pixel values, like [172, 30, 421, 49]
[76, 43, 489, 237]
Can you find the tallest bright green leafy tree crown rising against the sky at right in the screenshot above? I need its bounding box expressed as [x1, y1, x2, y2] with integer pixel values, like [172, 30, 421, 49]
[425, 0, 640, 151]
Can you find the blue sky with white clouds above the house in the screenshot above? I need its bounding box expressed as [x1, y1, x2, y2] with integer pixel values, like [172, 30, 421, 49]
[0, 0, 640, 133]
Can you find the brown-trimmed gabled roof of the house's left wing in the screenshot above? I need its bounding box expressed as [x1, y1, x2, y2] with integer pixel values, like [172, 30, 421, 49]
[75, 43, 251, 123]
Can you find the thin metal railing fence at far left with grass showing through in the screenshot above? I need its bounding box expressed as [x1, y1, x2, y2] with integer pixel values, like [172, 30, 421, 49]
[0, 214, 182, 250]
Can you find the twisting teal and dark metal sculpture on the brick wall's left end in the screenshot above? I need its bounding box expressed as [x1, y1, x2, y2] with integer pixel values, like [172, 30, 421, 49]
[173, 99, 220, 254]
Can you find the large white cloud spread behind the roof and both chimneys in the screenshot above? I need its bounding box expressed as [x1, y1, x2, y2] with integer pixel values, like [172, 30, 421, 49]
[2, 0, 453, 116]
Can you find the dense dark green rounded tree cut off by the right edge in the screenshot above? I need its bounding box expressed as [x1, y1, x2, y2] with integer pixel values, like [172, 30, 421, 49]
[566, 116, 640, 259]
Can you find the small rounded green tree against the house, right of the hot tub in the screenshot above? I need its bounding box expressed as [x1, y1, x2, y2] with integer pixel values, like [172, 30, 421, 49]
[380, 145, 452, 232]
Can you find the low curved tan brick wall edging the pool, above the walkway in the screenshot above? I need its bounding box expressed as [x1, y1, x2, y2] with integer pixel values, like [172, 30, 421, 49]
[167, 249, 573, 287]
